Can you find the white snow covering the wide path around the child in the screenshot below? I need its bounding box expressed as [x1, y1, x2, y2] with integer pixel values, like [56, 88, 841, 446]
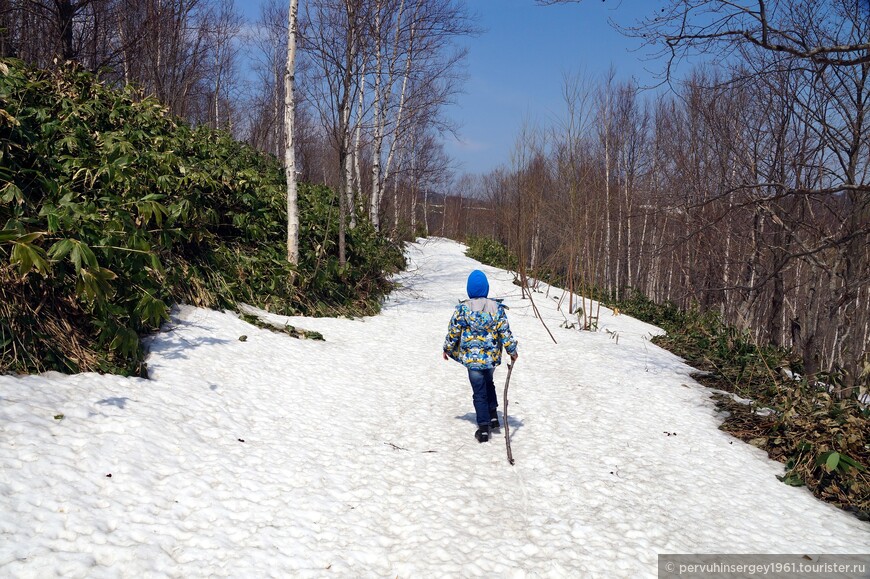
[0, 239, 870, 577]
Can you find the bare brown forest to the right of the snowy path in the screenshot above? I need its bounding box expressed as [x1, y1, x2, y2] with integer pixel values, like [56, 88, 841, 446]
[454, 0, 870, 404]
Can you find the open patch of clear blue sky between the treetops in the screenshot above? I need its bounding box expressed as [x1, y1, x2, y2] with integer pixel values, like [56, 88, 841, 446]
[447, 0, 659, 173]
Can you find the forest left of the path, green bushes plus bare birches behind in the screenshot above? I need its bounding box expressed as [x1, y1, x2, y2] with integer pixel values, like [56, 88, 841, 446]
[0, 0, 474, 374]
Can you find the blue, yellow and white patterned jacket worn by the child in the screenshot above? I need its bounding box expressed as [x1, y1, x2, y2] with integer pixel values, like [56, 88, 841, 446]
[444, 298, 517, 370]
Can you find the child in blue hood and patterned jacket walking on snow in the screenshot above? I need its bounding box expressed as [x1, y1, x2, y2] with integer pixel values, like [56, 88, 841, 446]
[443, 269, 518, 442]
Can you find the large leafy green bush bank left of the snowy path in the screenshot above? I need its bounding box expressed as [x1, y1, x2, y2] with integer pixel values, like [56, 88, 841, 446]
[0, 60, 402, 374]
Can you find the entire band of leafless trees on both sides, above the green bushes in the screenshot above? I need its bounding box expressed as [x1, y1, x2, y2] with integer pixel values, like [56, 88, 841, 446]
[0, 0, 870, 392]
